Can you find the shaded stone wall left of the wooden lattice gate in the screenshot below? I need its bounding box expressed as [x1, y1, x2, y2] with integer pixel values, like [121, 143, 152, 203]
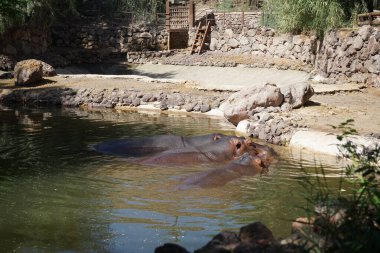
[0, 18, 168, 67]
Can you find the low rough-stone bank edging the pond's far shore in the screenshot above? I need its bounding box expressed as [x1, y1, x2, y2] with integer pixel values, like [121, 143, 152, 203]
[0, 74, 312, 145]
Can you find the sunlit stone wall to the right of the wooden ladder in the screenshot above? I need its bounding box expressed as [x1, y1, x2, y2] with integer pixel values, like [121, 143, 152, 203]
[190, 12, 317, 64]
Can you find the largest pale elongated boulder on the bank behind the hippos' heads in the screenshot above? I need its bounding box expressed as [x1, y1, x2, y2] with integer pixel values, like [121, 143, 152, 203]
[220, 83, 284, 125]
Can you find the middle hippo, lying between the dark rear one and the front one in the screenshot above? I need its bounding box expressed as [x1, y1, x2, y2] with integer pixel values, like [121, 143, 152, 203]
[140, 136, 250, 165]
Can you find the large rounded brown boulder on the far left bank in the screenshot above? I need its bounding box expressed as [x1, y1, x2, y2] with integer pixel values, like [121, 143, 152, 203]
[15, 59, 43, 85]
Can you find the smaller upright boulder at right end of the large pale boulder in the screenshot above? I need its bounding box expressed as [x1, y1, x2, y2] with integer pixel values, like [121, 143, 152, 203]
[281, 83, 314, 109]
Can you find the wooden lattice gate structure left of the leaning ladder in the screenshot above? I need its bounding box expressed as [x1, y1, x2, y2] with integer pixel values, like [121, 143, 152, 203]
[166, 0, 195, 49]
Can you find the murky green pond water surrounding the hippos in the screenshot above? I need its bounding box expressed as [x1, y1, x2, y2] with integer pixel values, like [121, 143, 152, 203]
[0, 106, 338, 252]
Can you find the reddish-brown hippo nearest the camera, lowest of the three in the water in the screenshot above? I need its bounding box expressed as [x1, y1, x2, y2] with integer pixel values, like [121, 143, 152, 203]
[176, 152, 268, 190]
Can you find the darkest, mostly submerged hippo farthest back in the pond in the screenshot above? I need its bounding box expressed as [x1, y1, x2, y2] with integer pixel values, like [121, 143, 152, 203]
[94, 133, 226, 157]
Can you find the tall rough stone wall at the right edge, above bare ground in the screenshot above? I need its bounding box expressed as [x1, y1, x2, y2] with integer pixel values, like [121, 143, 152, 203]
[316, 26, 380, 87]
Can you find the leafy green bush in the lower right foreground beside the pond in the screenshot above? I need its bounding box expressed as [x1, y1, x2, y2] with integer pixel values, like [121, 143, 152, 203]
[304, 120, 380, 253]
